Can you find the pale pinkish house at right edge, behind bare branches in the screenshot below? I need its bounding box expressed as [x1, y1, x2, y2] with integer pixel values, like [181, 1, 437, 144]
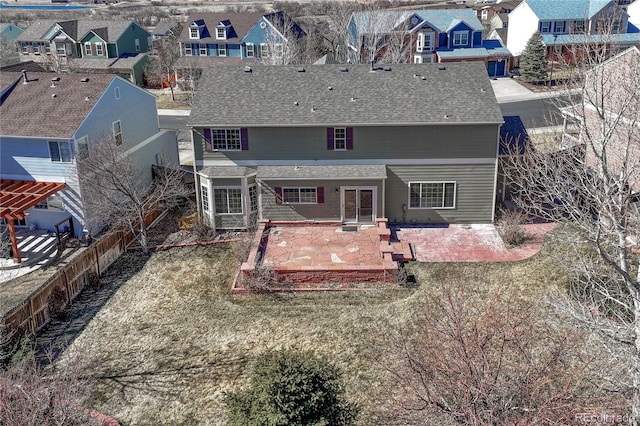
[562, 47, 640, 193]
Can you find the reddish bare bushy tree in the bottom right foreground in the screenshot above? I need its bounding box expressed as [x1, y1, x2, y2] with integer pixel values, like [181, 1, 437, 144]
[374, 276, 617, 425]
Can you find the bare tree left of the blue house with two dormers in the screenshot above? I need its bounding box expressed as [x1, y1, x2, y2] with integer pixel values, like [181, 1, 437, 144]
[144, 24, 182, 101]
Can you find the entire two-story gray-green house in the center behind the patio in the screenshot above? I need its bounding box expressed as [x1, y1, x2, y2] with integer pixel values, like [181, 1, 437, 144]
[188, 62, 503, 229]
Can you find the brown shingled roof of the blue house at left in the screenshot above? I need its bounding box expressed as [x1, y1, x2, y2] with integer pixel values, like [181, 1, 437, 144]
[0, 72, 115, 139]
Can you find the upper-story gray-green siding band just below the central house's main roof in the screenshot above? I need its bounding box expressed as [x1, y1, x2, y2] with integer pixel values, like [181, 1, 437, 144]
[193, 124, 498, 165]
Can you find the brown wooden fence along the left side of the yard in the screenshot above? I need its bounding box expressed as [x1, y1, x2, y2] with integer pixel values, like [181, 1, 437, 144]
[1, 212, 159, 340]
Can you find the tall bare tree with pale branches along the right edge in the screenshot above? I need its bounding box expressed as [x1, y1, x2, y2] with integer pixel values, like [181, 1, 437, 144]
[509, 27, 640, 424]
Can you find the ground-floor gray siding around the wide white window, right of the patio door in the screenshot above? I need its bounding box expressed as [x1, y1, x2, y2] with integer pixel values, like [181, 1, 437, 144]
[385, 164, 496, 223]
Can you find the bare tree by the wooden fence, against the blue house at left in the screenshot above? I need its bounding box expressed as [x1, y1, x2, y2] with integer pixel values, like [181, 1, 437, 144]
[78, 137, 189, 254]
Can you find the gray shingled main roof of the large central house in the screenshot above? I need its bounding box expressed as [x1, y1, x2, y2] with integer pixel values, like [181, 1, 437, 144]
[189, 62, 502, 126]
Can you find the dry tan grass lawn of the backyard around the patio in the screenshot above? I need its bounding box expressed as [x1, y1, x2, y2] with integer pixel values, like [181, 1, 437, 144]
[61, 243, 562, 425]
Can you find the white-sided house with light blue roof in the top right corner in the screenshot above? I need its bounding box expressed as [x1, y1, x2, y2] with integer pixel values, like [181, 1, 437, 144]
[507, 0, 640, 60]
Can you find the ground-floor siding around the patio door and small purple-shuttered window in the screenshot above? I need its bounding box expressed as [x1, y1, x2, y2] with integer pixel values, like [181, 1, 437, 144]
[260, 180, 383, 220]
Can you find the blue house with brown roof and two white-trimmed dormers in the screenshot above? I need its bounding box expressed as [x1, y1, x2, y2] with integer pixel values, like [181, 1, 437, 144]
[178, 12, 306, 69]
